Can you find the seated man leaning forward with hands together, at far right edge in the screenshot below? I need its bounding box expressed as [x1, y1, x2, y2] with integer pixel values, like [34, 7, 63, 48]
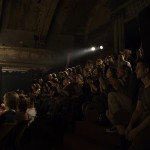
[126, 59, 150, 150]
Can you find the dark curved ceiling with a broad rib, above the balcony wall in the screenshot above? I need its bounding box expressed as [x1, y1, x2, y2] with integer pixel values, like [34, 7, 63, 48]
[0, 0, 125, 45]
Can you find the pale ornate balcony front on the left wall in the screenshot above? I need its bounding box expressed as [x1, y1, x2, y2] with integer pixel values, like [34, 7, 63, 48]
[0, 46, 53, 69]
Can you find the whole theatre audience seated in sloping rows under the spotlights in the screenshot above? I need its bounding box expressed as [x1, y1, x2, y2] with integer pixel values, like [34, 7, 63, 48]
[0, 49, 150, 150]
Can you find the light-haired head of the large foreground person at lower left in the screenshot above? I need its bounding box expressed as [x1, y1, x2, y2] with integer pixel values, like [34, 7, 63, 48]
[4, 91, 19, 111]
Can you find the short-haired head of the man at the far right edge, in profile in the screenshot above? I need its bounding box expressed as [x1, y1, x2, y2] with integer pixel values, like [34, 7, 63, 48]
[135, 59, 150, 79]
